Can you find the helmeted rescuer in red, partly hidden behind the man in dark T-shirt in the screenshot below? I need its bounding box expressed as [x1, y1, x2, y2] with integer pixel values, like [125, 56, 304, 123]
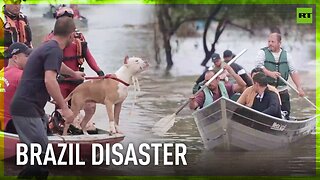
[46, 7, 104, 131]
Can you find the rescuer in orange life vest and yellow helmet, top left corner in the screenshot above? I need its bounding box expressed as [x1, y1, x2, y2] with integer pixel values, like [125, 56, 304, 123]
[1, 0, 32, 67]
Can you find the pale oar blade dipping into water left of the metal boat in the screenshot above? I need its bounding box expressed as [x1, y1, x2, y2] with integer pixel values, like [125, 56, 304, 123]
[152, 113, 176, 136]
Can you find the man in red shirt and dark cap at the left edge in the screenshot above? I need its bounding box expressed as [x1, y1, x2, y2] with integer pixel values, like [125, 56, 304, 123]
[1, 43, 32, 133]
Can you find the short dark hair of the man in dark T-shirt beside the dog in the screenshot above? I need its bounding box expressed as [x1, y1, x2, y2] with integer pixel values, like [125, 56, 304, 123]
[53, 16, 76, 37]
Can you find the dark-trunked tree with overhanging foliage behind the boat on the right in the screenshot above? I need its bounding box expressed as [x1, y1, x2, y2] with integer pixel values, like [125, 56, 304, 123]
[156, 4, 315, 69]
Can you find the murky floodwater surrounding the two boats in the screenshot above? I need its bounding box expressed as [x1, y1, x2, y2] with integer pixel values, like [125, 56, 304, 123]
[5, 5, 316, 176]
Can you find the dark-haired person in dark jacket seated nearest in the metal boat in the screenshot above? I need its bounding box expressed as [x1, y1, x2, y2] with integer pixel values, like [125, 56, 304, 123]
[245, 72, 281, 118]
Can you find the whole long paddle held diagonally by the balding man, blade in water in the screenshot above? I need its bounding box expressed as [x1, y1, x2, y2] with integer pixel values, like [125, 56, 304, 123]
[152, 49, 247, 136]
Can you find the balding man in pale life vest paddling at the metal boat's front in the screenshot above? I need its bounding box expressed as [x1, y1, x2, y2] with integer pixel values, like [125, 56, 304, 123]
[189, 64, 246, 110]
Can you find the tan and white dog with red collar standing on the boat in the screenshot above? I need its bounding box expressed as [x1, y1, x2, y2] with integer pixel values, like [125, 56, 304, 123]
[63, 56, 149, 135]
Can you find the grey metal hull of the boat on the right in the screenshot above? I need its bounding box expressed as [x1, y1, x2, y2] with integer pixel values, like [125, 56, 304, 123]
[193, 97, 317, 151]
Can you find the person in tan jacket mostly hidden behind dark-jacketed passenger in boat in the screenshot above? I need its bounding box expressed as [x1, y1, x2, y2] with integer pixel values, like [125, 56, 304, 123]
[237, 67, 281, 108]
